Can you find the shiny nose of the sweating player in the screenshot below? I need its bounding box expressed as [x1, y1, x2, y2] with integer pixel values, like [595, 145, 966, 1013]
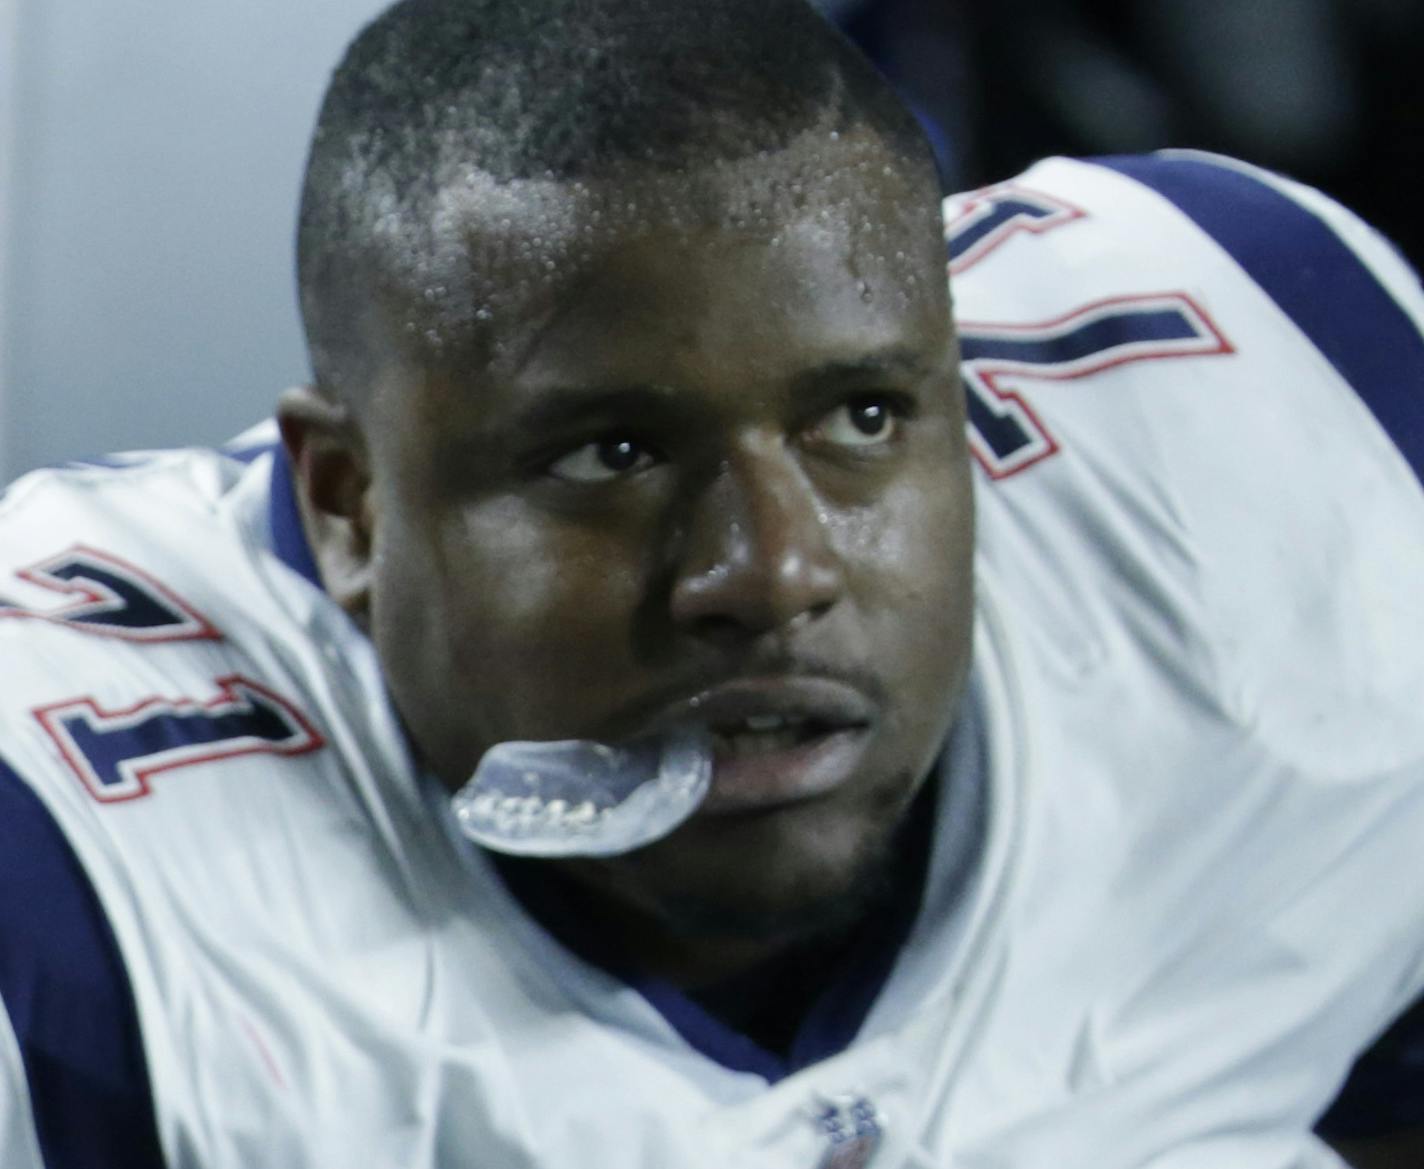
[672, 449, 844, 636]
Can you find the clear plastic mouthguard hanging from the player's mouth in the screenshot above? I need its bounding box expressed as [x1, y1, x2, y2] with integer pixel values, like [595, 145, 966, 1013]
[450, 728, 712, 857]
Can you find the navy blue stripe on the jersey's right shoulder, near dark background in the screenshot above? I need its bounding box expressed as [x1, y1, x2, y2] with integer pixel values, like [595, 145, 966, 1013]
[1094, 155, 1424, 484]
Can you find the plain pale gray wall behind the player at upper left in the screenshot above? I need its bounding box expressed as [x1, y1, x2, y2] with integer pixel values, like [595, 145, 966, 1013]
[0, 0, 382, 481]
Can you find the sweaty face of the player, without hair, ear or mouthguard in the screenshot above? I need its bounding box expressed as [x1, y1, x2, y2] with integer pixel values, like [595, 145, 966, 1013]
[343, 138, 973, 951]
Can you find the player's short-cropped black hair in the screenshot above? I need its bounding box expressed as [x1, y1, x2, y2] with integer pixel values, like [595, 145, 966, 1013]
[298, 0, 937, 390]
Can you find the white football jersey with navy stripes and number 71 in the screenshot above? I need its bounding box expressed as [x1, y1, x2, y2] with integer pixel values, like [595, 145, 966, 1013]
[0, 155, 1424, 1169]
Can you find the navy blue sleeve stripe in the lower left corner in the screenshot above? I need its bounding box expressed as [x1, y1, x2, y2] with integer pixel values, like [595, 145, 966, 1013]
[0, 760, 164, 1169]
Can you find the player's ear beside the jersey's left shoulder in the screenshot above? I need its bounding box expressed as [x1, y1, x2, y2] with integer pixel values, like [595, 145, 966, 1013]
[276, 386, 373, 625]
